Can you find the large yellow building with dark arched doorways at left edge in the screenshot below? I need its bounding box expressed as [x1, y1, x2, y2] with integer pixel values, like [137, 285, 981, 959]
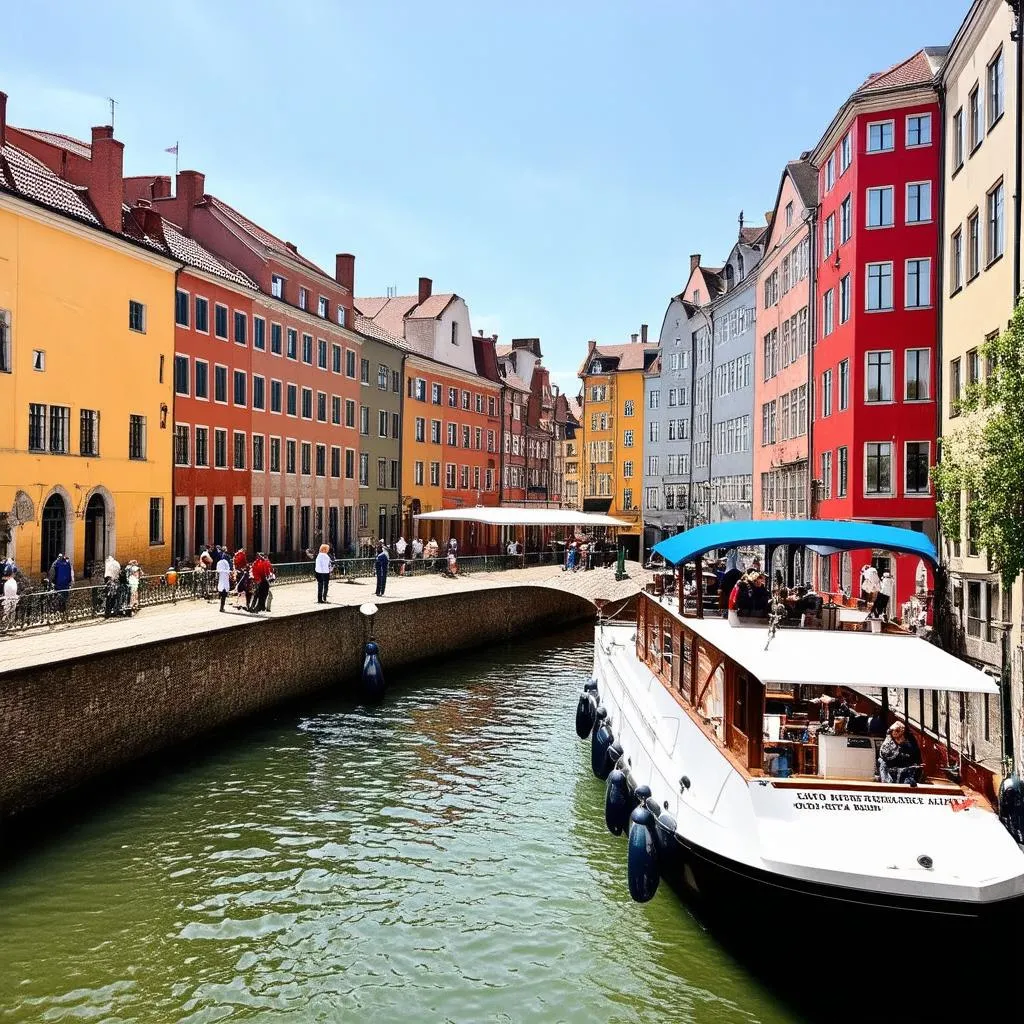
[0, 121, 179, 580]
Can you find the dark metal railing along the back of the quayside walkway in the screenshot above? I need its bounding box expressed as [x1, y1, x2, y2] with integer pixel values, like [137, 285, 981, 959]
[0, 551, 598, 636]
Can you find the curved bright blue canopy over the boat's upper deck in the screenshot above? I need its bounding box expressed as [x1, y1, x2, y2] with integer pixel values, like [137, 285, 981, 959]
[654, 519, 939, 565]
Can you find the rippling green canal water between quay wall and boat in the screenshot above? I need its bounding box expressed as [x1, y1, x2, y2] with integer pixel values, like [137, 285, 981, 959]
[0, 629, 798, 1024]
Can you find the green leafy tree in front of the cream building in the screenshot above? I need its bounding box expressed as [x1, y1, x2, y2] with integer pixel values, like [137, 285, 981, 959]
[932, 300, 1024, 587]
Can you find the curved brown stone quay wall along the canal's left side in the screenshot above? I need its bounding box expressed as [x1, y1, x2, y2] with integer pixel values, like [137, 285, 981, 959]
[0, 586, 595, 819]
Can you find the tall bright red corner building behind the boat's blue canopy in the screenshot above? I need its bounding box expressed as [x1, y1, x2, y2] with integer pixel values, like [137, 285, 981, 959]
[811, 48, 944, 603]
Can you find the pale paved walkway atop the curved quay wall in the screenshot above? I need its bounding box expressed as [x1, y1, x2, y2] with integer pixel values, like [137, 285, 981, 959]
[0, 562, 649, 677]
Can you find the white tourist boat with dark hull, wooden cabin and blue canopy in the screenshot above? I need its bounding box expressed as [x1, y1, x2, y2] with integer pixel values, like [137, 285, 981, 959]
[577, 520, 1024, 942]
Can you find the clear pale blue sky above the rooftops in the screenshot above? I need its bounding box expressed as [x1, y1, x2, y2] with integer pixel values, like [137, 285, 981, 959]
[6, 0, 970, 390]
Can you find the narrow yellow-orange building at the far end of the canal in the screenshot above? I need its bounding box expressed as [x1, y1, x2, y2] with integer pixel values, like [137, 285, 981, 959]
[580, 336, 657, 558]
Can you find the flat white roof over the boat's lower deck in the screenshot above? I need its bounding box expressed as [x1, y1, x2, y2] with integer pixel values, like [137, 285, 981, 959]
[667, 616, 999, 694]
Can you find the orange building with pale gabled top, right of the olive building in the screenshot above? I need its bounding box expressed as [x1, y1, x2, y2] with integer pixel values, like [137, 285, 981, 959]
[355, 278, 502, 554]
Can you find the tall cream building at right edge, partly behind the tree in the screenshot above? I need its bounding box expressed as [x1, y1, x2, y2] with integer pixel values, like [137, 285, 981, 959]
[937, 0, 1024, 768]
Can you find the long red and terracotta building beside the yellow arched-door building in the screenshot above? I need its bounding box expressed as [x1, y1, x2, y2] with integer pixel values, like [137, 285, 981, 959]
[125, 171, 365, 558]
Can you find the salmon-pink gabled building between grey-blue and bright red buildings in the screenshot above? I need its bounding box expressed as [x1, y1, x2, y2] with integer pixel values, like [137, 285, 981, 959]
[754, 161, 818, 519]
